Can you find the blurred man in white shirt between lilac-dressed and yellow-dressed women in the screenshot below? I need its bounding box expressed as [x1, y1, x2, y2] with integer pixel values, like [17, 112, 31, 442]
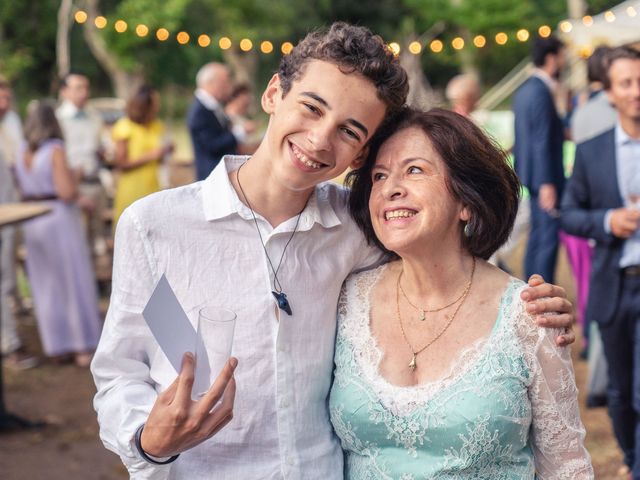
[56, 72, 107, 254]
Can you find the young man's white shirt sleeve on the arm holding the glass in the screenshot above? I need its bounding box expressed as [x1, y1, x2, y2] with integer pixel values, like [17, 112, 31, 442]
[91, 208, 171, 480]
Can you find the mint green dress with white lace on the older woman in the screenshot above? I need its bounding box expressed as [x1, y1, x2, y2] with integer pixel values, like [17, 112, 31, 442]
[329, 266, 593, 480]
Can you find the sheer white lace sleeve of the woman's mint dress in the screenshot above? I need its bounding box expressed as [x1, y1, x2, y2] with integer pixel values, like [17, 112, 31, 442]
[514, 291, 594, 480]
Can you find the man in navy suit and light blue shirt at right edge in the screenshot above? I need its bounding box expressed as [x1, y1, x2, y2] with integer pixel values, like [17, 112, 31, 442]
[562, 47, 640, 479]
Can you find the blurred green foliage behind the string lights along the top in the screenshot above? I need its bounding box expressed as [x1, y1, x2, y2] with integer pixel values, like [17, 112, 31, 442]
[0, 0, 632, 107]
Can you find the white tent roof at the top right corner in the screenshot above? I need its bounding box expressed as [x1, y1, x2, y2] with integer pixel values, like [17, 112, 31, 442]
[560, 0, 640, 52]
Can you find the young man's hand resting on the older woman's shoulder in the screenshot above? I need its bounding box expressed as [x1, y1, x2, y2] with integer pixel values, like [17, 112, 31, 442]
[520, 275, 576, 346]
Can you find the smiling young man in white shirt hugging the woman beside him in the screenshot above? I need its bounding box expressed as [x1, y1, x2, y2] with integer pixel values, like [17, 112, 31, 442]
[92, 23, 573, 479]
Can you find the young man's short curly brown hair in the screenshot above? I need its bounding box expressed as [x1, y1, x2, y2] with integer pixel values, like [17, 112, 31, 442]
[278, 22, 409, 113]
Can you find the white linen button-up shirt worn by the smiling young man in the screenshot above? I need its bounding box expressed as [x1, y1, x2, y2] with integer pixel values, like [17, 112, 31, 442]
[92, 156, 381, 480]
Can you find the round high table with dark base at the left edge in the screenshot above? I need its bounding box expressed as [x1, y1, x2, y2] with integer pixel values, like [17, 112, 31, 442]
[0, 202, 51, 432]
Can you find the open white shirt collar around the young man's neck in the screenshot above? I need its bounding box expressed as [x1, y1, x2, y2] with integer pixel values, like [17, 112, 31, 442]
[202, 155, 342, 230]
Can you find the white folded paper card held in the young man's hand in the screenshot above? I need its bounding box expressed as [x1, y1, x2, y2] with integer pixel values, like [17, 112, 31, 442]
[142, 274, 209, 392]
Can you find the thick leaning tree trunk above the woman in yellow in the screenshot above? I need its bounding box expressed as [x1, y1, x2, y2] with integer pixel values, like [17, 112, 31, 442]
[82, 0, 144, 99]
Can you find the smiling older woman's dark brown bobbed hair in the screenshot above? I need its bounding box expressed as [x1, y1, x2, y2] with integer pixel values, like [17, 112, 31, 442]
[347, 108, 520, 259]
